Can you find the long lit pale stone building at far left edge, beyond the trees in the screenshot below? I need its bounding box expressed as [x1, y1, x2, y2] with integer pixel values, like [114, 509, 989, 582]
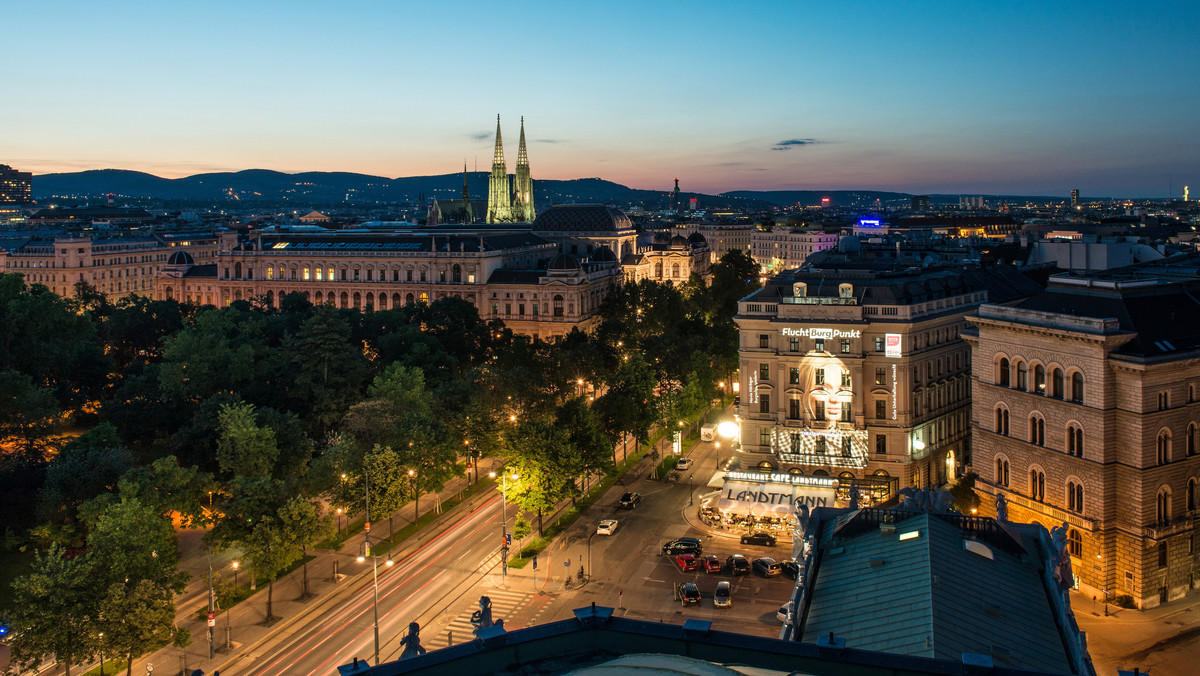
[0, 232, 217, 301]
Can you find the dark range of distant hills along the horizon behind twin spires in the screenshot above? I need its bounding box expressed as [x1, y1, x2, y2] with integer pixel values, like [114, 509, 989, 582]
[34, 169, 1054, 210]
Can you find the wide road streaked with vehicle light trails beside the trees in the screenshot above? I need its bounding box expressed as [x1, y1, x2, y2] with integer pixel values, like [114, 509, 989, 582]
[221, 496, 514, 676]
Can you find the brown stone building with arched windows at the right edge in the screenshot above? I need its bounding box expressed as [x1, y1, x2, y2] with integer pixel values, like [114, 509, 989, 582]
[965, 256, 1200, 608]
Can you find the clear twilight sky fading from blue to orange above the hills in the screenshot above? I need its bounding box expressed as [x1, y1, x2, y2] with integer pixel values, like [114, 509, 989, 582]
[0, 0, 1200, 197]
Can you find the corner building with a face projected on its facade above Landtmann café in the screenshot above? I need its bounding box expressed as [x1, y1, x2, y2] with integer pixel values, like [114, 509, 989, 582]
[736, 240, 1039, 503]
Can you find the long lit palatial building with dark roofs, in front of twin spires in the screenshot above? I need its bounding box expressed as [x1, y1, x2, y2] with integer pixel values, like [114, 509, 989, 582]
[158, 204, 709, 339]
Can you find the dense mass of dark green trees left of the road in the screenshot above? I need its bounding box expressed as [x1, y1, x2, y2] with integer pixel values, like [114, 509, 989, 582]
[0, 252, 755, 676]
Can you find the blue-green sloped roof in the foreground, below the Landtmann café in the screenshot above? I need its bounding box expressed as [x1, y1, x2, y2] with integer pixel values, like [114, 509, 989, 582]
[802, 514, 1070, 672]
